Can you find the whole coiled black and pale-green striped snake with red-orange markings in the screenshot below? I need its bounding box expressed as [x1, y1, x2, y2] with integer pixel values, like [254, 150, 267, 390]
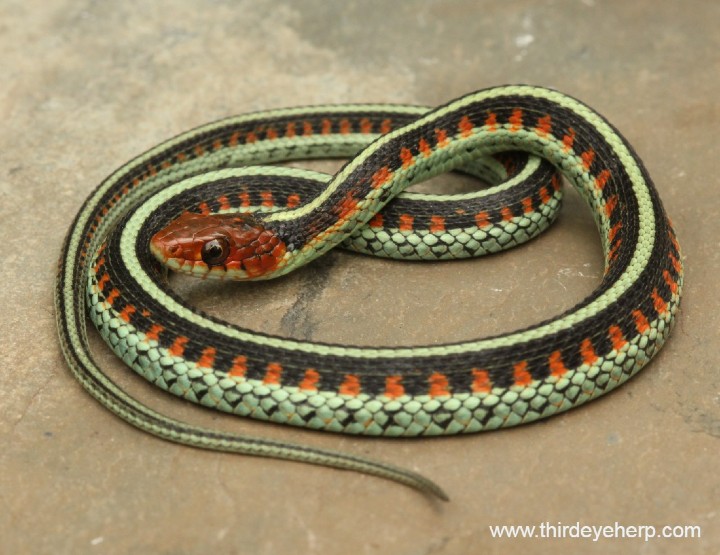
[55, 85, 683, 500]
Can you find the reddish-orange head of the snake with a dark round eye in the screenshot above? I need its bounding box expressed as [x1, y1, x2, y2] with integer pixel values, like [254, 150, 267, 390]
[150, 212, 286, 280]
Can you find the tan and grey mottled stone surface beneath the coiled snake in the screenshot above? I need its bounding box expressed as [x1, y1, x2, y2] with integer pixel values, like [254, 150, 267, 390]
[0, 0, 720, 555]
